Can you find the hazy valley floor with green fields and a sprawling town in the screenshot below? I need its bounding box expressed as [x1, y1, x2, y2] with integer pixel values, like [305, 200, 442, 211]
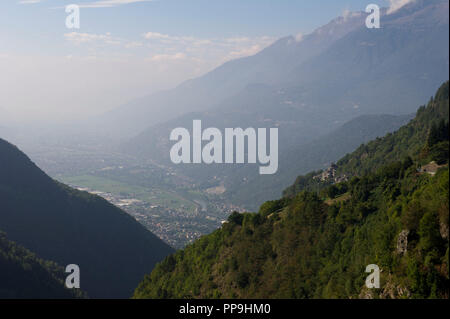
[24, 146, 243, 249]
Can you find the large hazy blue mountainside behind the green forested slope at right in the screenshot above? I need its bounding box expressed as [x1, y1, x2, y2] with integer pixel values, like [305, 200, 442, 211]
[121, 0, 449, 209]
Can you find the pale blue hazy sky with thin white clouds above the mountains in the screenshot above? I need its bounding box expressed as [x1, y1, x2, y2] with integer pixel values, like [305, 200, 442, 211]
[0, 0, 408, 124]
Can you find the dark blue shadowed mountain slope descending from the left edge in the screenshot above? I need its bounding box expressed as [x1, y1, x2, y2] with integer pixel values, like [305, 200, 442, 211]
[0, 139, 173, 298]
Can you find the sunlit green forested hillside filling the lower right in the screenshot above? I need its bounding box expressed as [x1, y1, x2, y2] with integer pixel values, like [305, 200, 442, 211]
[134, 82, 449, 298]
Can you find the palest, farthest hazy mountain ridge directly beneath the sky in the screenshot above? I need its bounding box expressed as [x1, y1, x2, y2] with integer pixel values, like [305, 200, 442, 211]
[94, 4, 372, 136]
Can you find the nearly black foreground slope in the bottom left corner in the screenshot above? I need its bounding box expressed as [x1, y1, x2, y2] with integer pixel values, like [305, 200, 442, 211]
[0, 232, 84, 299]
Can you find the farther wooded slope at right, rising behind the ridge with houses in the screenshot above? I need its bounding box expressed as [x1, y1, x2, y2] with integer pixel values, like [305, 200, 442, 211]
[284, 83, 449, 196]
